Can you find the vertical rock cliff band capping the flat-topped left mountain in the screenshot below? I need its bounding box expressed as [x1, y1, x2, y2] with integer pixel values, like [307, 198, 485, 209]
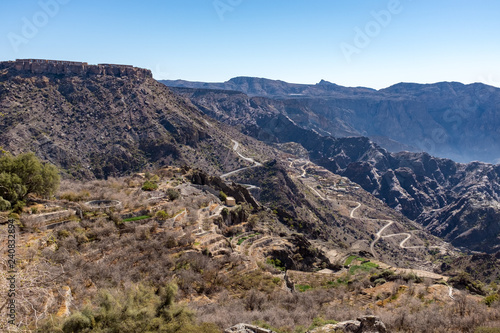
[0, 59, 153, 78]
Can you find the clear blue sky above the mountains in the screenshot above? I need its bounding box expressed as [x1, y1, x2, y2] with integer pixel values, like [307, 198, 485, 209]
[0, 0, 500, 88]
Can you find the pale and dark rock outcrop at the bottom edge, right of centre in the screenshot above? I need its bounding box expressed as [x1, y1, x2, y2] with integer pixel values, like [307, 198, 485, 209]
[309, 316, 387, 333]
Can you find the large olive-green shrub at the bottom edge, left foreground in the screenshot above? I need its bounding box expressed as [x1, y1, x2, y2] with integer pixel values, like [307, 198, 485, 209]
[38, 284, 219, 333]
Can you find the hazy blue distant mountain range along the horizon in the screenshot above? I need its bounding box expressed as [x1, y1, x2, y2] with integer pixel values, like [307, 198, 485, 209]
[162, 77, 500, 162]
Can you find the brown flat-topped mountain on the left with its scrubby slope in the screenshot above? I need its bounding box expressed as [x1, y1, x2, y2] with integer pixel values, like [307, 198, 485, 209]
[0, 62, 274, 178]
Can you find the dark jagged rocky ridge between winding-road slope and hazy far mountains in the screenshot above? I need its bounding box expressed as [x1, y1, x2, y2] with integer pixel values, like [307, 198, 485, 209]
[168, 88, 500, 252]
